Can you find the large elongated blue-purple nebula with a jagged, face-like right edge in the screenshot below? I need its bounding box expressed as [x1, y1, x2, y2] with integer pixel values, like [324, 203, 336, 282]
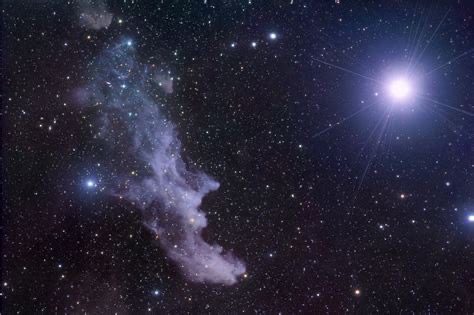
[86, 40, 245, 285]
